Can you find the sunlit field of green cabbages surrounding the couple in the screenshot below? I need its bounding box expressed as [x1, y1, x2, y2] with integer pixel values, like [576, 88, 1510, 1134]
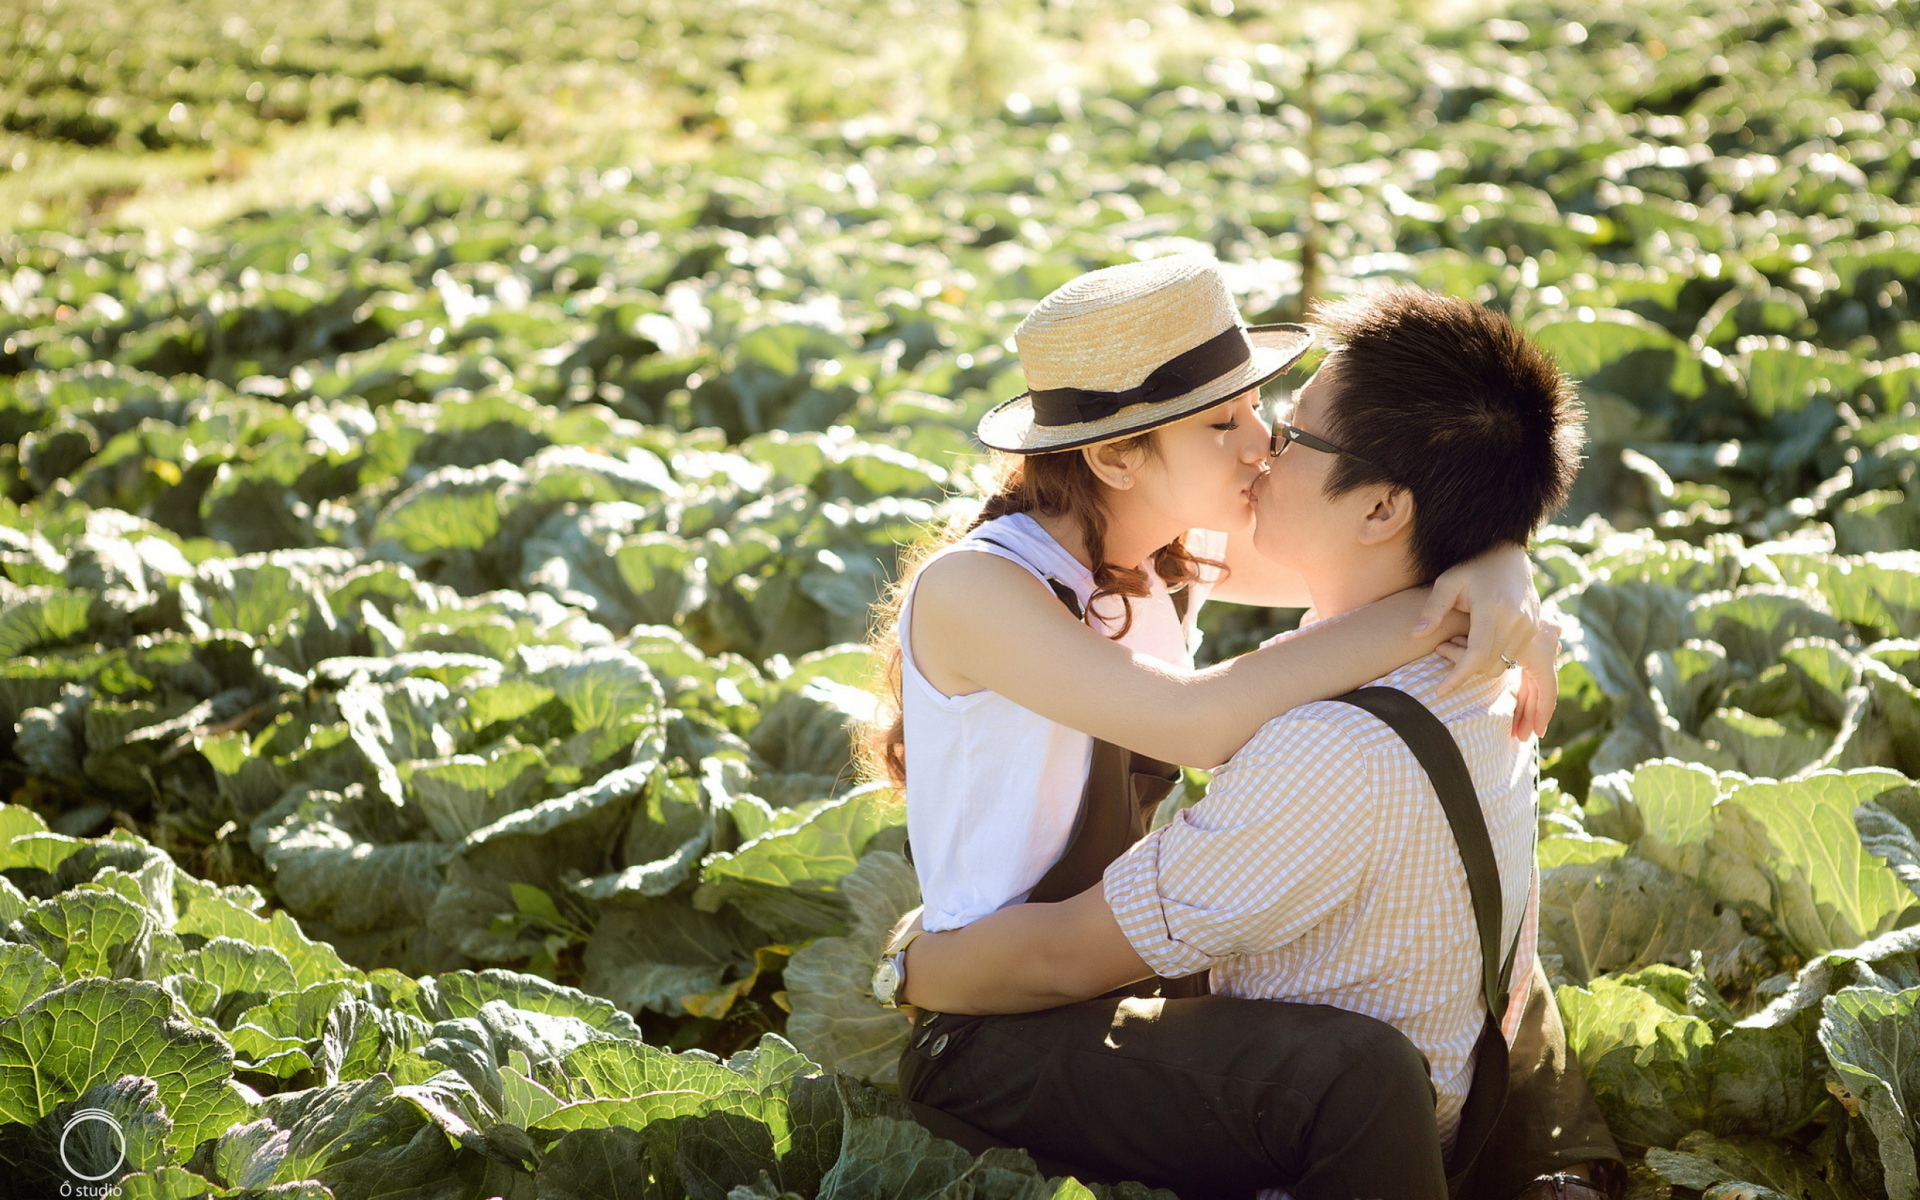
[0, 0, 1920, 1200]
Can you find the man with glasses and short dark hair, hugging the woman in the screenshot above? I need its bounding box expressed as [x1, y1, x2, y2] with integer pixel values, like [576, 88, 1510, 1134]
[902, 290, 1617, 1200]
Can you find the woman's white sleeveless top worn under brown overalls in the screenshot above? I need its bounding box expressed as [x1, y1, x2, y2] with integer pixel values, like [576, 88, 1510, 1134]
[899, 513, 1227, 929]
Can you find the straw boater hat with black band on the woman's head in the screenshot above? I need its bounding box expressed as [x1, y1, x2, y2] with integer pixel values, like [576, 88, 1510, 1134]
[979, 255, 1313, 455]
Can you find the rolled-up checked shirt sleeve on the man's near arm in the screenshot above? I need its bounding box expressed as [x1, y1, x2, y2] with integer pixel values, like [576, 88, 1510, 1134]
[1104, 705, 1377, 977]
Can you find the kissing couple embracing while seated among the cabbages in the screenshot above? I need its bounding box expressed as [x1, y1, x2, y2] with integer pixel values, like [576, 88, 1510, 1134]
[866, 257, 1620, 1200]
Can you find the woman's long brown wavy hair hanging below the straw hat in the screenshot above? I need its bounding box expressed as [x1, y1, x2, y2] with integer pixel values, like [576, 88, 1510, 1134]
[856, 432, 1227, 789]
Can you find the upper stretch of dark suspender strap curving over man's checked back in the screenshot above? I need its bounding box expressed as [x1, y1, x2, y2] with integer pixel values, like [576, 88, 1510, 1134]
[1334, 687, 1519, 1021]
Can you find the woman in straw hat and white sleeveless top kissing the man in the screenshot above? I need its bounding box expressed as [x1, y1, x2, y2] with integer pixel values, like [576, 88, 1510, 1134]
[866, 257, 1553, 1173]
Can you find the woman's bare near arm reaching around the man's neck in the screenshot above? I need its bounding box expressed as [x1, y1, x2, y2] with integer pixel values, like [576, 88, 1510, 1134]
[900, 555, 1467, 768]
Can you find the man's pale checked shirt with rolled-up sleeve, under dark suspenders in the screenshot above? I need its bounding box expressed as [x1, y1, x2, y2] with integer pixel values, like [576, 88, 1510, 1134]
[1106, 655, 1538, 1144]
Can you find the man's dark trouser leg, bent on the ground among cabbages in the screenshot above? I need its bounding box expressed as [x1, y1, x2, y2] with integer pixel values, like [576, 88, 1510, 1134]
[900, 996, 1448, 1200]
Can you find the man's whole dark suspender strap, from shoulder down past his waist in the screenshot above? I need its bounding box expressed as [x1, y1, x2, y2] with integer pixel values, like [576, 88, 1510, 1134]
[1334, 687, 1521, 1190]
